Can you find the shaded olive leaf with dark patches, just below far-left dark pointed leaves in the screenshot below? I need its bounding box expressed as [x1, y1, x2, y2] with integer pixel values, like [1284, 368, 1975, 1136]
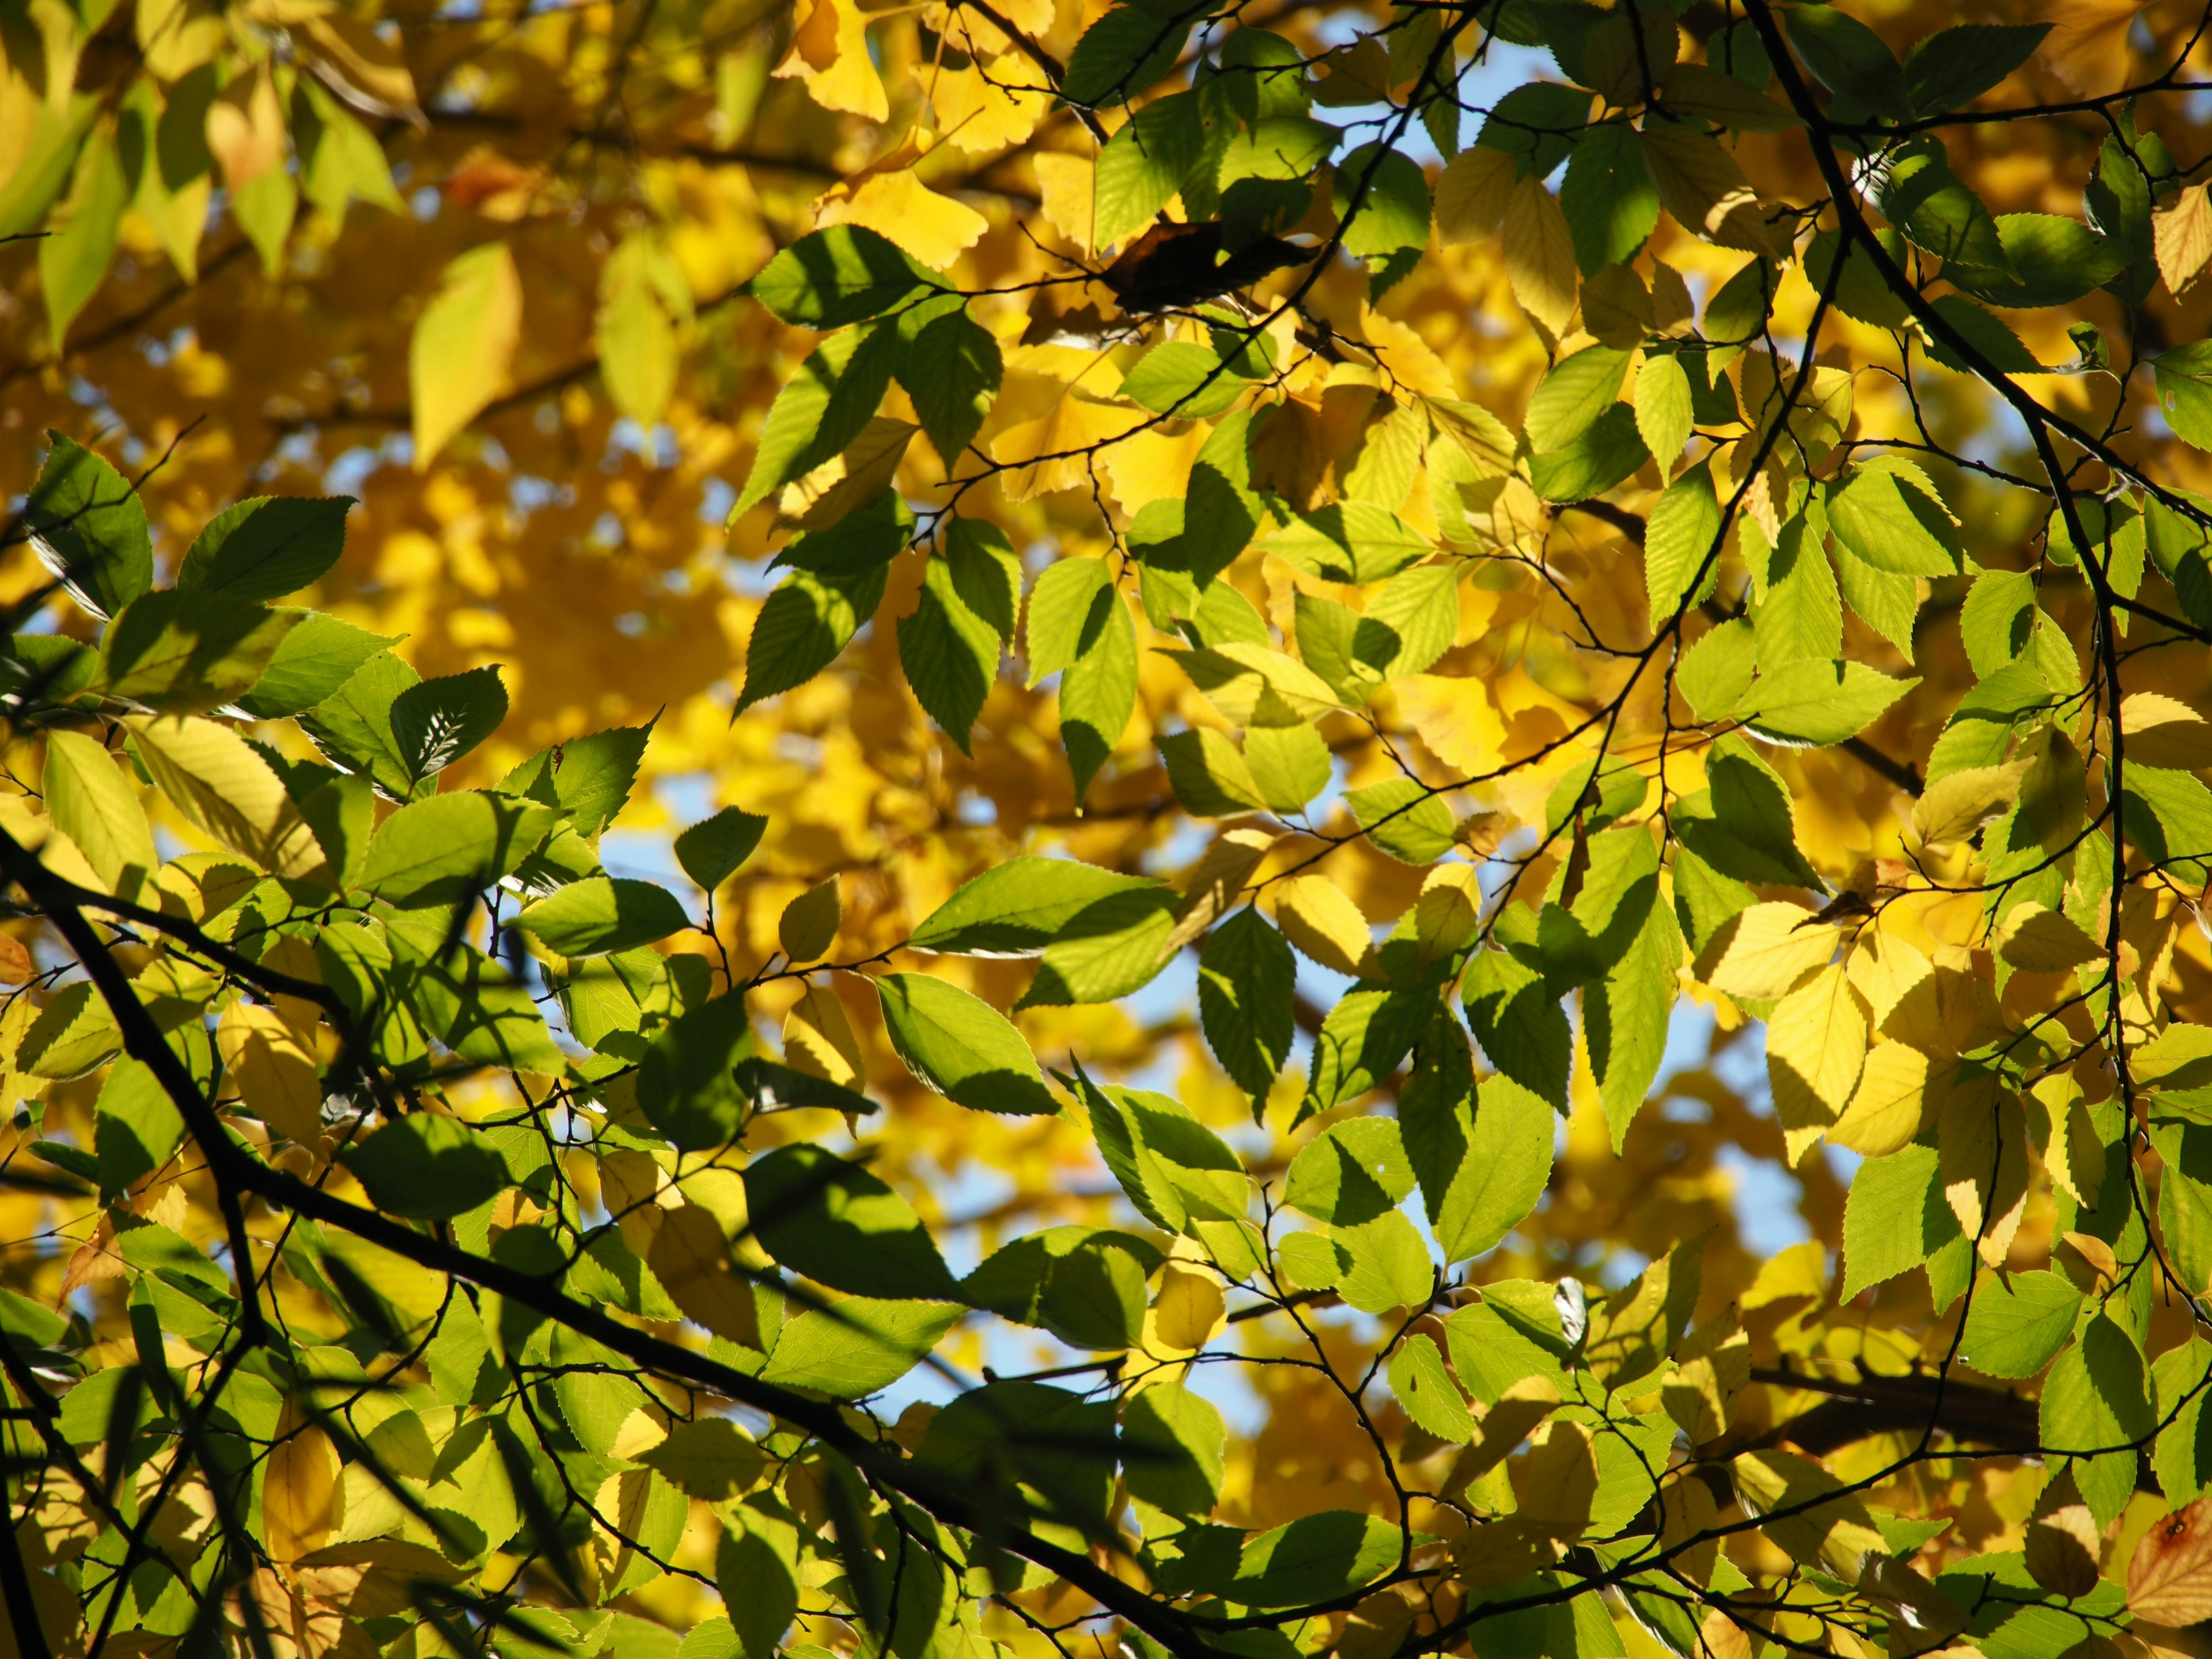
[90, 588, 298, 714]
